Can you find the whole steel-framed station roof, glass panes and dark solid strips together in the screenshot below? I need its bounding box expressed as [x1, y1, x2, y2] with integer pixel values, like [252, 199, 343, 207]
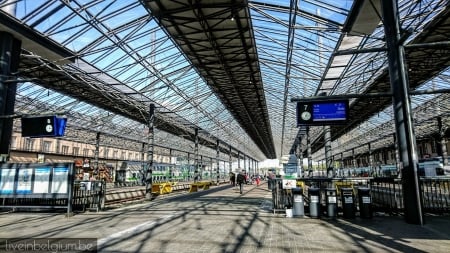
[0, 0, 450, 164]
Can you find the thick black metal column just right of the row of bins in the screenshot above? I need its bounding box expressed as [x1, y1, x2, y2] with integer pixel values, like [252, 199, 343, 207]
[381, 0, 424, 225]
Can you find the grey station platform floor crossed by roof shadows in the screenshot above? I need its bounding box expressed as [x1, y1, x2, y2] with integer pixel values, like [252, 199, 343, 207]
[0, 183, 450, 253]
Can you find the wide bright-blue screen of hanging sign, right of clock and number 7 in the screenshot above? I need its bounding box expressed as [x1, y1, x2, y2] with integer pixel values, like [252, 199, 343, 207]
[312, 101, 348, 121]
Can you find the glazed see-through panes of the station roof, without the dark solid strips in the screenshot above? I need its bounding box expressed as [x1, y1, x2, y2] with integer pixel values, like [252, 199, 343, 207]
[0, 0, 450, 164]
